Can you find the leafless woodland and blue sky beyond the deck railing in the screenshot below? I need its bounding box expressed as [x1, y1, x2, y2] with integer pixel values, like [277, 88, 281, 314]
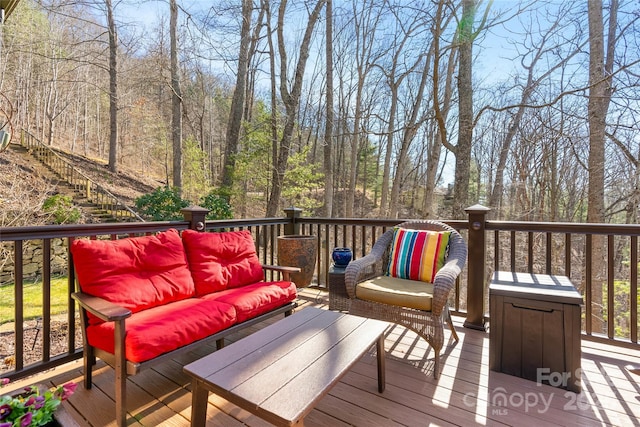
[0, 0, 640, 223]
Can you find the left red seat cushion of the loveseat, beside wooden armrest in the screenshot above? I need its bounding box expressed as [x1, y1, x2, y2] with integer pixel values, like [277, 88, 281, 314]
[87, 298, 236, 362]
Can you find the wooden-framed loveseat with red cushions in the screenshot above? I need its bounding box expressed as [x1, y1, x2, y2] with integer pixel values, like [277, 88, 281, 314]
[71, 229, 299, 425]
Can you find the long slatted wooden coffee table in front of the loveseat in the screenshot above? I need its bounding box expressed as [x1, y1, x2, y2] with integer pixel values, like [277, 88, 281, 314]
[184, 307, 389, 426]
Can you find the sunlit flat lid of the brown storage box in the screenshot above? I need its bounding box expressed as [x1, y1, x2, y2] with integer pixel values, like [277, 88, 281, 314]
[489, 271, 583, 305]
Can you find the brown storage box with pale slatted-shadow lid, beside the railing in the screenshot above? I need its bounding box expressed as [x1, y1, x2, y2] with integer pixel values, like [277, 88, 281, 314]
[489, 271, 582, 393]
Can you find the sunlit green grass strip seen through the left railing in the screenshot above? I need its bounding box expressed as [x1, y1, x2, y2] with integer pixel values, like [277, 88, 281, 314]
[0, 277, 68, 325]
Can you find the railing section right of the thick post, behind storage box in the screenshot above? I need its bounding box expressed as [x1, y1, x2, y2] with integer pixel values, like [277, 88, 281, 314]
[486, 221, 640, 348]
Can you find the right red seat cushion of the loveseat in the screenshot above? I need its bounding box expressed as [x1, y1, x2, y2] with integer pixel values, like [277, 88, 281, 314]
[203, 281, 297, 322]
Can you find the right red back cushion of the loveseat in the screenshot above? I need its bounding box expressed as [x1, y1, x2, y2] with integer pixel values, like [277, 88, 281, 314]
[182, 230, 264, 296]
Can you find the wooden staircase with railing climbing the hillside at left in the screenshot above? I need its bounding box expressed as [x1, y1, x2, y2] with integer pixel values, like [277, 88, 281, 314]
[15, 130, 144, 222]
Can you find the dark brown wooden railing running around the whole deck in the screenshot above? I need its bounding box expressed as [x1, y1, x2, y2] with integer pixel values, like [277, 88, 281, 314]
[0, 206, 640, 379]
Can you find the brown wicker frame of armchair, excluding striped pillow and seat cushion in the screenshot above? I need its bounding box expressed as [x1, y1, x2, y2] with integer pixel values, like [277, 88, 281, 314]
[345, 220, 467, 379]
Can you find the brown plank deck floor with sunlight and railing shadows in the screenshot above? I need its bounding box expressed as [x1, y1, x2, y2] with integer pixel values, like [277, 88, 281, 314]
[3, 289, 640, 427]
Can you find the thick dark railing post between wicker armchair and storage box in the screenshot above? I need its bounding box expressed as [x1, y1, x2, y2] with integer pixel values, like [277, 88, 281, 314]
[464, 205, 491, 331]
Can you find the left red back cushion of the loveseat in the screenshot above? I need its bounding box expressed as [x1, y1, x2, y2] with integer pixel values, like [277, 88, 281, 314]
[71, 229, 194, 320]
